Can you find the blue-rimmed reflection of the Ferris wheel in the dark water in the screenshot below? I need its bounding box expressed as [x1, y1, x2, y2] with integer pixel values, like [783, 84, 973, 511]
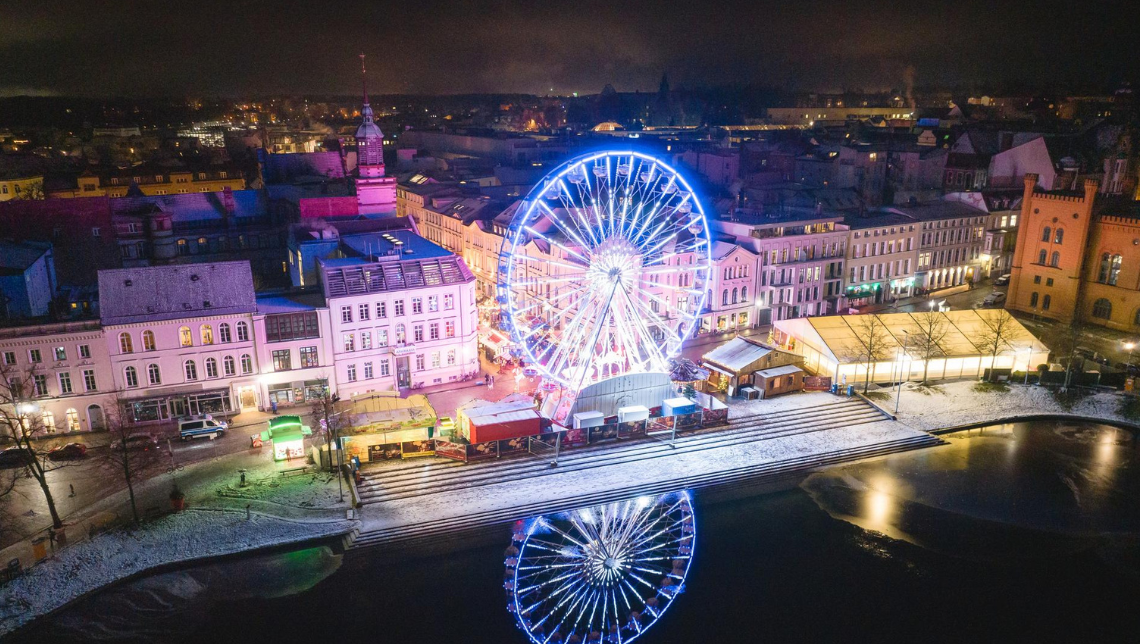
[506, 492, 697, 644]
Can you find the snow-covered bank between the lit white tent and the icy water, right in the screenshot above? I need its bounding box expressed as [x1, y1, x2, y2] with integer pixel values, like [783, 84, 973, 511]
[880, 381, 1130, 431]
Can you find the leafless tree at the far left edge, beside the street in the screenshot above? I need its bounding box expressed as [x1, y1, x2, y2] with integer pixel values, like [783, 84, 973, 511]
[0, 366, 64, 530]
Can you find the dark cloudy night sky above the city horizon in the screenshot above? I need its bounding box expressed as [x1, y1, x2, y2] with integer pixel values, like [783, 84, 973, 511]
[0, 0, 1140, 96]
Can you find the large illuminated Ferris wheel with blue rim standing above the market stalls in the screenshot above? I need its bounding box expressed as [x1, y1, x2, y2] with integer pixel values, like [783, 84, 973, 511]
[498, 152, 711, 392]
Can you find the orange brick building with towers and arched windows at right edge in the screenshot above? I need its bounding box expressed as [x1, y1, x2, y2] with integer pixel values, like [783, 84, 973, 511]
[1005, 174, 1140, 331]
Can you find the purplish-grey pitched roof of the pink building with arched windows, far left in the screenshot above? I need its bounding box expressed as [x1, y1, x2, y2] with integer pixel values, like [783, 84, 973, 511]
[99, 261, 258, 325]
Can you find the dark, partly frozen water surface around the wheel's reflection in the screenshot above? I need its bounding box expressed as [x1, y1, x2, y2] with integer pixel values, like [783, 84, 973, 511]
[16, 423, 1140, 644]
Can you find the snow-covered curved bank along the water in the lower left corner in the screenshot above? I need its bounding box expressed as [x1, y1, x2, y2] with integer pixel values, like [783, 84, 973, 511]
[0, 510, 356, 637]
